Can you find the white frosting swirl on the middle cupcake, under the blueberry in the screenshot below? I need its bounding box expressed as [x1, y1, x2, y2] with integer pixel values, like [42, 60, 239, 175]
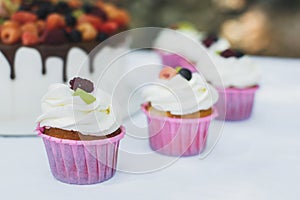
[142, 73, 218, 115]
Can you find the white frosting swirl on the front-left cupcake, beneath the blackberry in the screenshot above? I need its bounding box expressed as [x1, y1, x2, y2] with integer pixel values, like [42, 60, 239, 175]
[36, 84, 120, 136]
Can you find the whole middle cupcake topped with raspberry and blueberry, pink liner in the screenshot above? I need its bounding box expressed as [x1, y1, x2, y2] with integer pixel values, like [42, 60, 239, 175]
[142, 67, 218, 156]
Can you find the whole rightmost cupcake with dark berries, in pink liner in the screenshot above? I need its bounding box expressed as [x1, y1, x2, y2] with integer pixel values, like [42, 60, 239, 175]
[198, 49, 261, 121]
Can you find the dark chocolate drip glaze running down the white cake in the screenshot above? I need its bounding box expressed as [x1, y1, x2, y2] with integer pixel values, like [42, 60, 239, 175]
[0, 41, 99, 82]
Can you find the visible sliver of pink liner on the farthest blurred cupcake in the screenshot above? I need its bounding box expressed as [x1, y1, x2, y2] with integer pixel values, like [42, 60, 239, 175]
[157, 51, 197, 72]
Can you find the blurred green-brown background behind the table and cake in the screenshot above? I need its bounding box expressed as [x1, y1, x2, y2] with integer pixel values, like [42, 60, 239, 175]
[0, 0, 300, 58]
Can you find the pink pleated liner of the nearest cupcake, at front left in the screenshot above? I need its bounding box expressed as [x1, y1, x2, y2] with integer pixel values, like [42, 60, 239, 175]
[37, 126, 125, 185]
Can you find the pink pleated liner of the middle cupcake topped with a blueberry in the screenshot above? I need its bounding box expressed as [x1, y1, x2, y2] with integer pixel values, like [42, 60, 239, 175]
[142, 103, 217, 156]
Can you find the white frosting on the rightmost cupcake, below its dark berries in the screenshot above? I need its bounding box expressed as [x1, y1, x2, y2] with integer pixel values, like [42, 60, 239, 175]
[197, 53, 261, 88]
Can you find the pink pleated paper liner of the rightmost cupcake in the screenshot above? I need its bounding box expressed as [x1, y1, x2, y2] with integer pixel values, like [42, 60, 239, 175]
[216, 86, 259, 121]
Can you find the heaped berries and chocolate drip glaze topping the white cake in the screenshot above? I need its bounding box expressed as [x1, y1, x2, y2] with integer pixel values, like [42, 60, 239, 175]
[0, 0, 129, 81]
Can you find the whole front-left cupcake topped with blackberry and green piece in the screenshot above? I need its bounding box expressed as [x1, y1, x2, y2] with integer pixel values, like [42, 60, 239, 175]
[37, 78, 125, 184]
